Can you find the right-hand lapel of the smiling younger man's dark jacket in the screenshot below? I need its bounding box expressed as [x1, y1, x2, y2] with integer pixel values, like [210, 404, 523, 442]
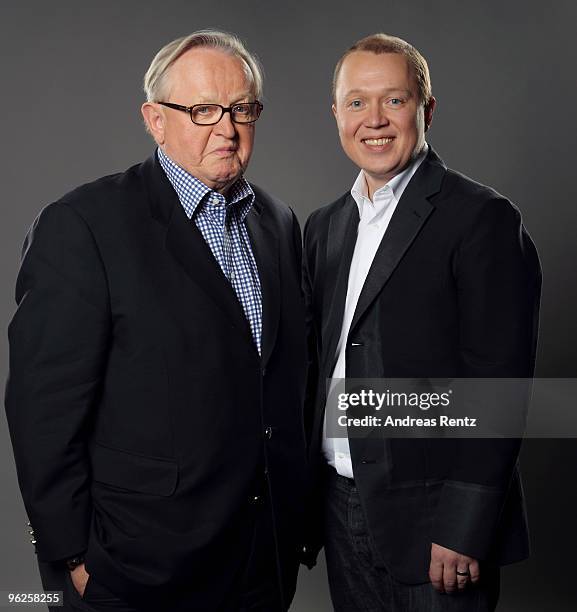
[351, 149, 446, 331]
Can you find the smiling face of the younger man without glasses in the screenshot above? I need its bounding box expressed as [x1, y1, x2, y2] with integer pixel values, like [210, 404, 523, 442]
[333, 51, 435, 192]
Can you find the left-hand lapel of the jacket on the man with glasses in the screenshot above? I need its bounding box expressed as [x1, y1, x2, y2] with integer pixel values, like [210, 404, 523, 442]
[142, 154, 254, 346]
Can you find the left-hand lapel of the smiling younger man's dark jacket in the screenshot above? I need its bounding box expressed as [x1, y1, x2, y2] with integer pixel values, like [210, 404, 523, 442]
[322, 193, 359, 374]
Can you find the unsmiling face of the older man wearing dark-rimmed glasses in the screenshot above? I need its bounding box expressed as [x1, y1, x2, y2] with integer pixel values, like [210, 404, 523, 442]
[142, 48, 255, 193]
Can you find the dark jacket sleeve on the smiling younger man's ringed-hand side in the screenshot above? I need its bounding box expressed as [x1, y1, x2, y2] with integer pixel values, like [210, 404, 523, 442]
[431, 198, 541, 559]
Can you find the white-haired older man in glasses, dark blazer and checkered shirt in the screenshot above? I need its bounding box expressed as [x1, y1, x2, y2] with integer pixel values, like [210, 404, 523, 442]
[6, 31, 306, 611]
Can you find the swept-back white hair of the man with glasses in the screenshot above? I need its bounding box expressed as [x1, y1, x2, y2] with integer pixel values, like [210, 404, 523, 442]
[144, 30, 263, 102]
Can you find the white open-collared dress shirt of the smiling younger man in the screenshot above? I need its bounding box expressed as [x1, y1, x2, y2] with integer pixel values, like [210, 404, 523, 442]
[323, 144, 429, 478]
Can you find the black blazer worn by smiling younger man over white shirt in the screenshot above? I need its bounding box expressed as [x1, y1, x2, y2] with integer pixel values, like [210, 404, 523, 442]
[304, 149, 541, 583]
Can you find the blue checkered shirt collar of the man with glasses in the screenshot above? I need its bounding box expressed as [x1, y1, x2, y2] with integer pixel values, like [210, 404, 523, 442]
[156, 147, 255, 221]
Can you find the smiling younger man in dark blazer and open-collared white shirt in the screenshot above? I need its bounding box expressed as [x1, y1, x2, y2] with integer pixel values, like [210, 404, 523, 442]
[304, 34, 540, 612]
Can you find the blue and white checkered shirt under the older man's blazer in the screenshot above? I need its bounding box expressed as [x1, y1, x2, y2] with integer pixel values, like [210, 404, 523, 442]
[157, 147, 262, 354]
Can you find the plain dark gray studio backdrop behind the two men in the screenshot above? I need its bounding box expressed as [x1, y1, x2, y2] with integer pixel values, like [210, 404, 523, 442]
[0, 0, 577, 612]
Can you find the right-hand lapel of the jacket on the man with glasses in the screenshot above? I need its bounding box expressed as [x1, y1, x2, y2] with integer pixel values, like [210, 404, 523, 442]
[246, 200, 280, 367]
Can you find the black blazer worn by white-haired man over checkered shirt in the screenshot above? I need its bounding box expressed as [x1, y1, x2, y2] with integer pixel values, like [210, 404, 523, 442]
[6, 156, 307, 609]
